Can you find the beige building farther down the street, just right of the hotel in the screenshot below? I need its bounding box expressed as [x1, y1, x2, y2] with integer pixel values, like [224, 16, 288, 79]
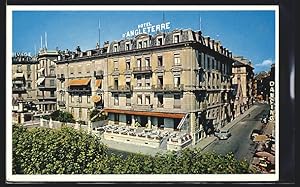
[232, 56, 254, 117]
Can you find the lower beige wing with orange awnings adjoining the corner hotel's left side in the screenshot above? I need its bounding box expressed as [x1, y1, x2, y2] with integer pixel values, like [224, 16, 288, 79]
[56, 44, 108, 122]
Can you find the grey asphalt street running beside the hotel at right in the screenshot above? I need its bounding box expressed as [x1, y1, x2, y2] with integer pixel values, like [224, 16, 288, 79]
[203, 104, 269, 162]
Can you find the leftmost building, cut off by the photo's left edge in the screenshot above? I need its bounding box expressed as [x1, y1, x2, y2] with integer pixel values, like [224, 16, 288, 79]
[12, 54, 38, 123]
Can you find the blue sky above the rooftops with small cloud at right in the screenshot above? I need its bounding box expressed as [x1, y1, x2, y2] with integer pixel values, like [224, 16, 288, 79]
[12, 10, 275, 73]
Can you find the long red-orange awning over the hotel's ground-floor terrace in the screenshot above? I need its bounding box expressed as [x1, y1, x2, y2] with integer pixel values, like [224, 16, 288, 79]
[104, 109, 185, 119]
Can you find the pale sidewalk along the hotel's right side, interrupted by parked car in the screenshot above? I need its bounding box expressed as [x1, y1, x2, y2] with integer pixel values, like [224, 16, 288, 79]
[190, 105, 258, 150]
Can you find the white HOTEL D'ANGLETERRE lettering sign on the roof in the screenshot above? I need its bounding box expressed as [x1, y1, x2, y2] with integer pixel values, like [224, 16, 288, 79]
[122, 22, 171, 38]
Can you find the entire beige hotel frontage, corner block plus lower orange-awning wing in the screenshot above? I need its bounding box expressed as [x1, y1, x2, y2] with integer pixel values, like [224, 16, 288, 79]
[56, 29, 235, 143]
